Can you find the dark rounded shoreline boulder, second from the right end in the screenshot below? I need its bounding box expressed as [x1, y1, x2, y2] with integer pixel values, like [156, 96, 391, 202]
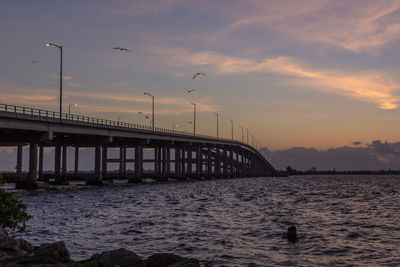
[91, 248, 146, 267]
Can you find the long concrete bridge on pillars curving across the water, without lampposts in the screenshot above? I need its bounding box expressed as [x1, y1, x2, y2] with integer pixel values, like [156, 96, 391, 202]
[0, 104, 278, 188]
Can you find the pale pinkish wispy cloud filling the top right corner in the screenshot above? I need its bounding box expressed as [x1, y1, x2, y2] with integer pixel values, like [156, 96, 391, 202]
[211, 0, 400, 53]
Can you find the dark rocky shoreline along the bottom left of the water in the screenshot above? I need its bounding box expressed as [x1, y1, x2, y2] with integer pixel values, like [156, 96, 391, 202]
[0, 228, 200, 267]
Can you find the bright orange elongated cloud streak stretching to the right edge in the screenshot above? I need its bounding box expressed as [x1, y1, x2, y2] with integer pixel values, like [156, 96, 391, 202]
[151, 47, 400, 109]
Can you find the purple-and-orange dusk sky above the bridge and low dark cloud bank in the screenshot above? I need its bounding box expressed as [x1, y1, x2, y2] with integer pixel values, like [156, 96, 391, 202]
[0, 0, 400, 150]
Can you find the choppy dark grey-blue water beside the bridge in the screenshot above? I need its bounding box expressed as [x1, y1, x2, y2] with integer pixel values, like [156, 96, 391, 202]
[14, 176, 400, 266]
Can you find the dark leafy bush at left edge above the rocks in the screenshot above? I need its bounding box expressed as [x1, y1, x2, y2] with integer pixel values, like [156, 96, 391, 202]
[0, 175, 32, 232]
